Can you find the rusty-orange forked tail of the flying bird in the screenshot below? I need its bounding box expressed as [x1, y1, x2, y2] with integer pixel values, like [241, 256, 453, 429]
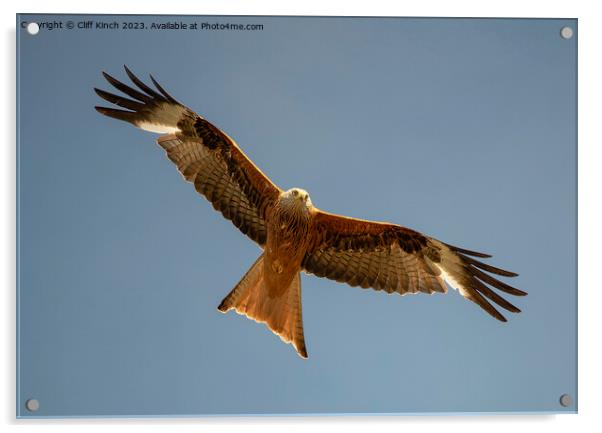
[217, 254, 307, 358]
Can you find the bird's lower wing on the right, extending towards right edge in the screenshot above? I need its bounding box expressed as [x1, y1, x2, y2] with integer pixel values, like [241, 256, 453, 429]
[302, 209, 526, 322]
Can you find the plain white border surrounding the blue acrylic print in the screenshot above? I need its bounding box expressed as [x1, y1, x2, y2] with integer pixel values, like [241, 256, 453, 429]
[0, 0, 602, 433]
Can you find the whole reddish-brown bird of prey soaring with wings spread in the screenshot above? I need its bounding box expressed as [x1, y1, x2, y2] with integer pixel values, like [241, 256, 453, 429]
[94, 67, 526, 358]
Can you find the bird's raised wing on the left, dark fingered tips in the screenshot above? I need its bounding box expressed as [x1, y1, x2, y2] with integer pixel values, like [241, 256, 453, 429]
[94, 67, 281, 245]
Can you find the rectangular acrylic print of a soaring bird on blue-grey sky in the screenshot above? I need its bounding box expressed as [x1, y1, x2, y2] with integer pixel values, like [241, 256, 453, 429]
[17, 15, 577, 417]
